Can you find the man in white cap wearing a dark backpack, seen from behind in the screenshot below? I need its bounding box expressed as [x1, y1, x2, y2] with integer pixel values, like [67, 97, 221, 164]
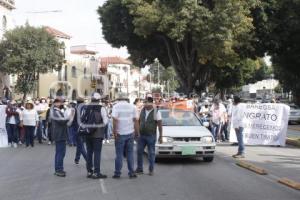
[82, 93, 108, 179]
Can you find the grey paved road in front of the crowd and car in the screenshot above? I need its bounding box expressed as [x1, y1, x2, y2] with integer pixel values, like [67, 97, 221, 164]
[0, 145, 300, 200]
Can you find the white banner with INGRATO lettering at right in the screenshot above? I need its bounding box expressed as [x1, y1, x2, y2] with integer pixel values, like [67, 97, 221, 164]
[230, 103, 290, 146]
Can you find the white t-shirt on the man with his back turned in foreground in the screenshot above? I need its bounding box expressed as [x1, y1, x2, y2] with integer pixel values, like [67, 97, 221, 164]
[112, 101, 138, 135]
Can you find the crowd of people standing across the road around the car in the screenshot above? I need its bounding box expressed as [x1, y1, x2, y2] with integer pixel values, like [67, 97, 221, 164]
[2, 93, 244, 179]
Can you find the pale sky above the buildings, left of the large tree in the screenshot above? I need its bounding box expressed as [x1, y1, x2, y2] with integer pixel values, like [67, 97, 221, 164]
[13, 0, 129, 58]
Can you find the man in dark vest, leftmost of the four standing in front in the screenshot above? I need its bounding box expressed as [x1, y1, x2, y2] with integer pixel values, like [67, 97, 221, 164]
[50, 98, 74, 177]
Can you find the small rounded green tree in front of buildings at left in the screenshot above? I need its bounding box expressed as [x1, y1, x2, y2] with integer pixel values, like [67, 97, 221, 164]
[0, 24, 63, 98]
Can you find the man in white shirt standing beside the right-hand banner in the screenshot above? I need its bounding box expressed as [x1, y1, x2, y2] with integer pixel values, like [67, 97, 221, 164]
[231, 96, 245, 158]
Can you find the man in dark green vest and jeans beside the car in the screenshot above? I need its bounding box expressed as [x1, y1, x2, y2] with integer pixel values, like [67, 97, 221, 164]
[136, 97, 162, 176]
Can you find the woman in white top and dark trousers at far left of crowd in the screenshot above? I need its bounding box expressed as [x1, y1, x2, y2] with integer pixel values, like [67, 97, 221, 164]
[20, 101, 39, 147]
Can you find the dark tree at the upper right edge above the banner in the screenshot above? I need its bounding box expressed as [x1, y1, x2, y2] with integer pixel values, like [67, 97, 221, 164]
[253, 0, 300, 104]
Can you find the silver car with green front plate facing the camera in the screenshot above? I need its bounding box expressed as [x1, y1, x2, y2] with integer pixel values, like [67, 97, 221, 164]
[156, 109, 216, 162]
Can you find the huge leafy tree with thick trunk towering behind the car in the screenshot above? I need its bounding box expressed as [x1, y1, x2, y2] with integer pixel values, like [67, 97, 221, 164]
[98, 0, 258, 93]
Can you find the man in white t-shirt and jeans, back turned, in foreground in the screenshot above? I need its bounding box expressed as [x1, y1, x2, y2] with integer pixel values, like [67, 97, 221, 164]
[112, 94, 139, 179]
